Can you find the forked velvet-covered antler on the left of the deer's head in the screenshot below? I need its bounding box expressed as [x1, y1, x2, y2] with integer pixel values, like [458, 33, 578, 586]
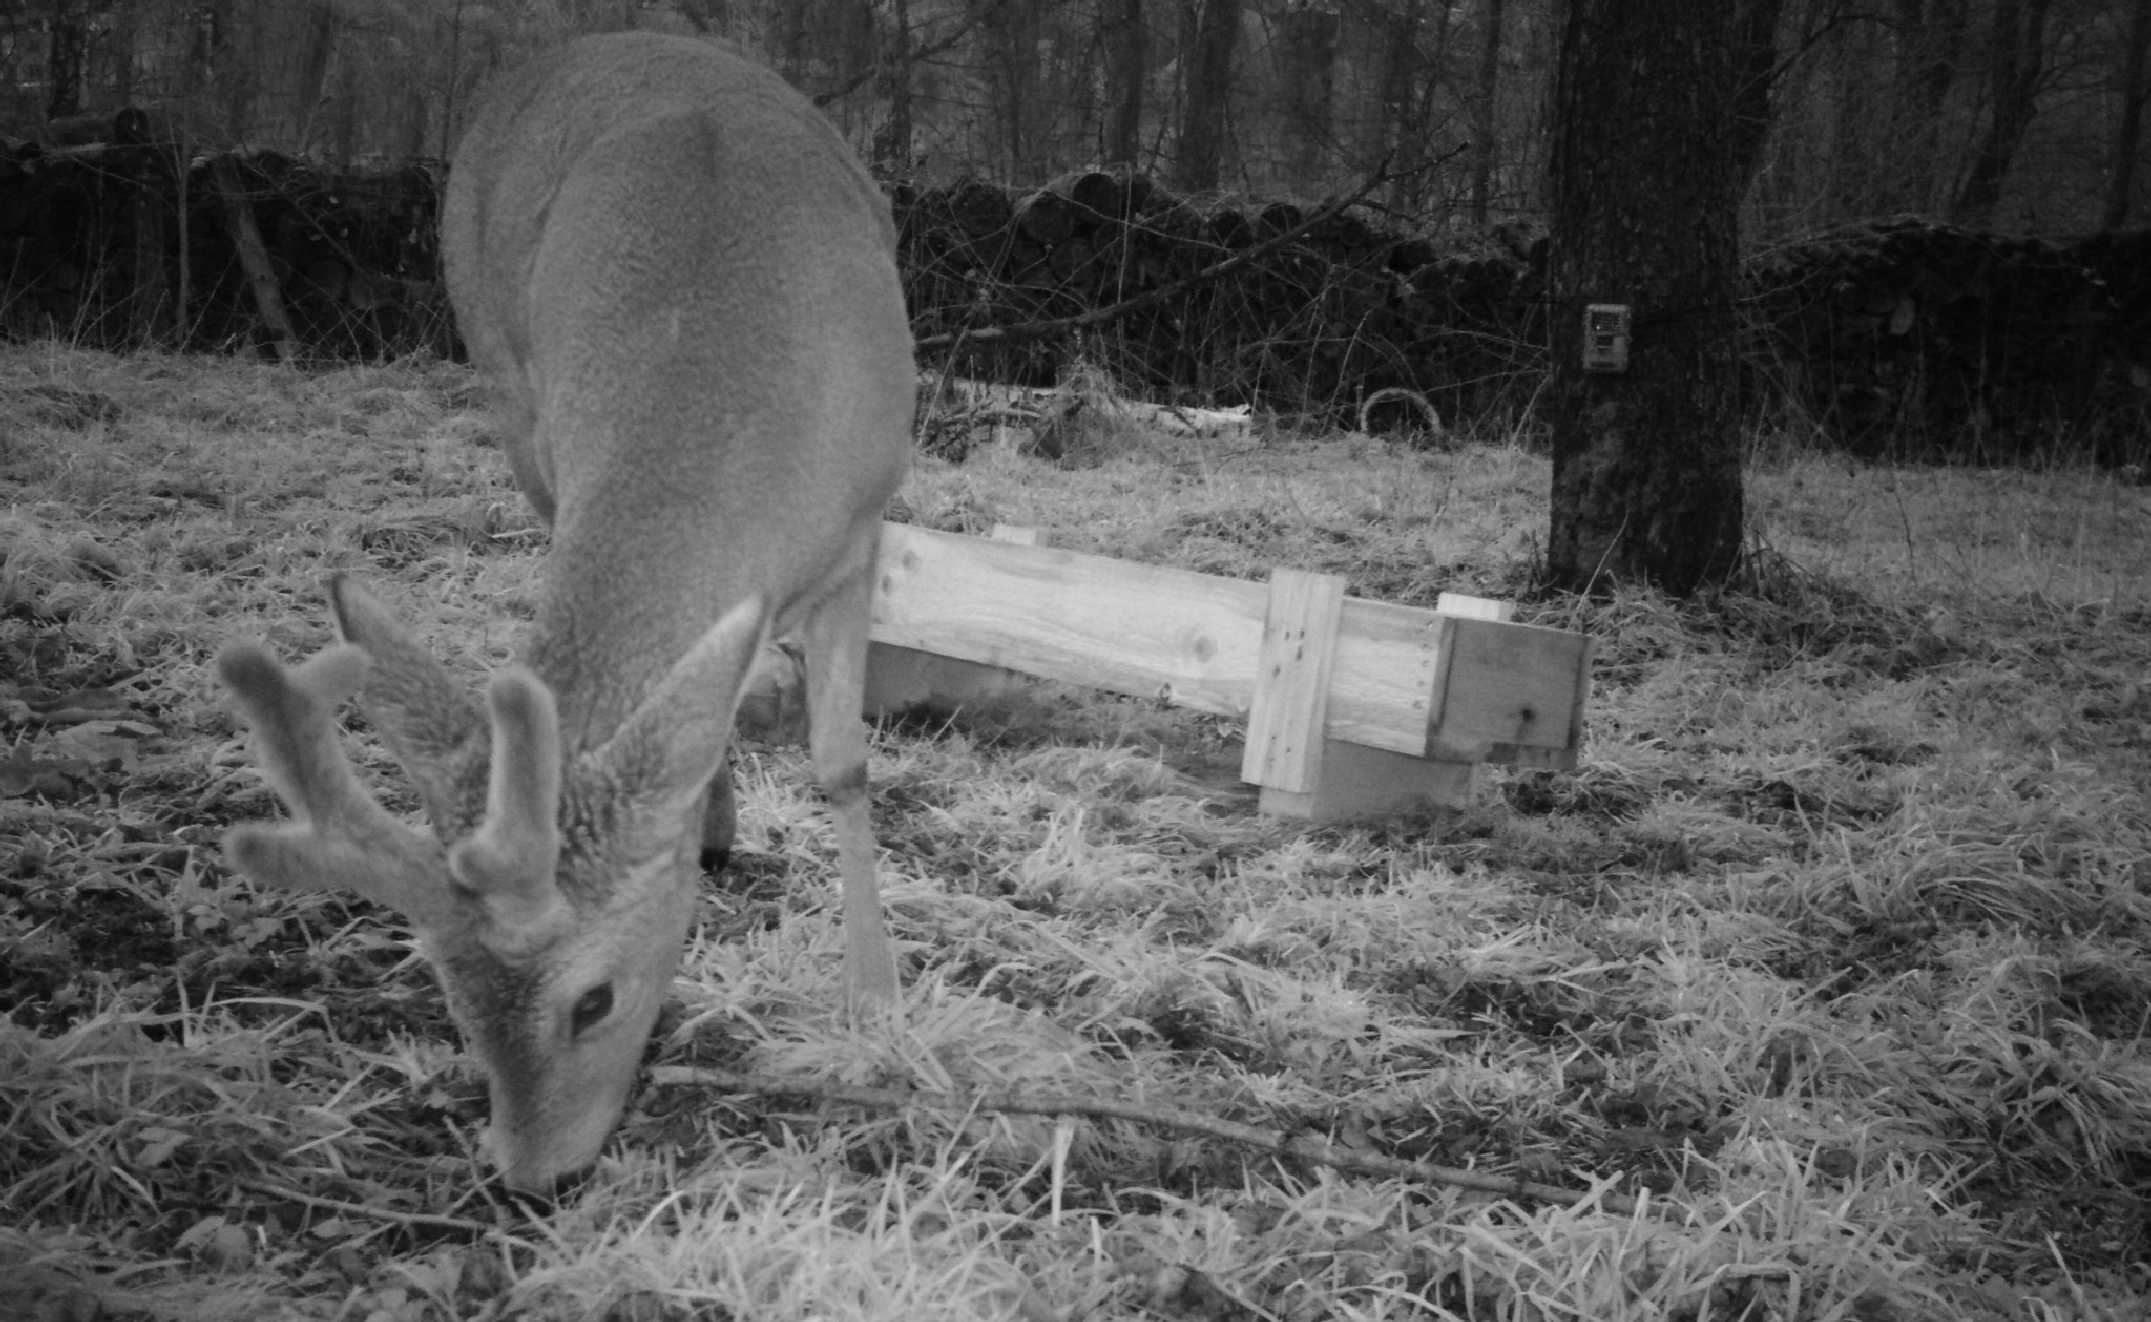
[217, 643, 439, 922]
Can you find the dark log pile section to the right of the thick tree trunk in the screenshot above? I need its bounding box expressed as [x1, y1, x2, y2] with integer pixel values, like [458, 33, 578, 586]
[1744, 226, 2151, 466]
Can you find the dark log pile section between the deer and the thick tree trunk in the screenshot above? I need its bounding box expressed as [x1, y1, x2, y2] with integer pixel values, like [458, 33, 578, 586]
[897, 170, 1544, 423]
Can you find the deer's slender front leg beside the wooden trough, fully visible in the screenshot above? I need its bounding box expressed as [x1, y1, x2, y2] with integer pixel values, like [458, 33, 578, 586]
[800, 559, 899, 1015]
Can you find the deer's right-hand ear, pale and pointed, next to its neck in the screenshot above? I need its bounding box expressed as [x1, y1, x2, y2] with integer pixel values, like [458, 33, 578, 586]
[589, 598, 770, 800]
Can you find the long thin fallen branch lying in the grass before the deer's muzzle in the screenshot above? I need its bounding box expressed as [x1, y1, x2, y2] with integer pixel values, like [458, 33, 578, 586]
[656, 1066, 1637, 1217]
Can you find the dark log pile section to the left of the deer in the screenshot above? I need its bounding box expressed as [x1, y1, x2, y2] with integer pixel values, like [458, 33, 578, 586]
[0, 127, 454, 359]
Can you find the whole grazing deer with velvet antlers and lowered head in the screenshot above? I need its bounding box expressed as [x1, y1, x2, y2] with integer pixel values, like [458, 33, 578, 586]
[217, 32, 914, 1195]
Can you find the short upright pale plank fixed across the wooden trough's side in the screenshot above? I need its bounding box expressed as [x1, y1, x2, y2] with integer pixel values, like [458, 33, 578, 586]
[1239, 570, 1344, 815]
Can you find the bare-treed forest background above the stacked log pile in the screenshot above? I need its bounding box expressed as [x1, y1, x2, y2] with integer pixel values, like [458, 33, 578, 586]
[0, 0, 2151, 243]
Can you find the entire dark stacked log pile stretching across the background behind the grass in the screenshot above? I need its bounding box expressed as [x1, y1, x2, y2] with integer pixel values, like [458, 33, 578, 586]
[0, 130, 2151, 466]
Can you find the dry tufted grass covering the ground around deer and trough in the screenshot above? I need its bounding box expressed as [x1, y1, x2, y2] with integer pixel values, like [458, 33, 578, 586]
[0, 346, 2151, 1322]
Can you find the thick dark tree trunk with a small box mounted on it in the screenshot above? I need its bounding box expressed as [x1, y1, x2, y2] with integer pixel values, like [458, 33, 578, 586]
[1547, 0, 1742, 593]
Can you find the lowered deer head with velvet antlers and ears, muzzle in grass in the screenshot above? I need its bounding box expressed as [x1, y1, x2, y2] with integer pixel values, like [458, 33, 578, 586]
[217, 578, 766, 1191]
